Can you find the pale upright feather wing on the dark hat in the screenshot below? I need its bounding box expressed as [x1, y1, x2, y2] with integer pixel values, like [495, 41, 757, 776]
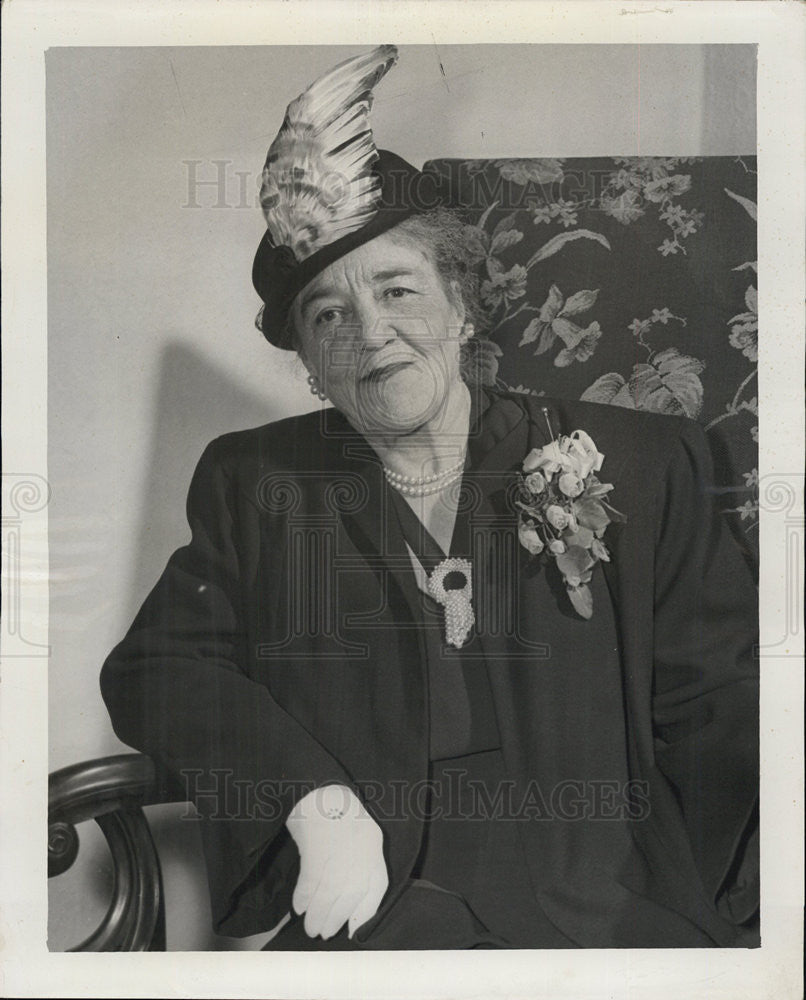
[260, 45, 397, 261]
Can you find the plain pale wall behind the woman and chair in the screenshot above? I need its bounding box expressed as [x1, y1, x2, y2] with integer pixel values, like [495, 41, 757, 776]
[46, 45, 755, 949]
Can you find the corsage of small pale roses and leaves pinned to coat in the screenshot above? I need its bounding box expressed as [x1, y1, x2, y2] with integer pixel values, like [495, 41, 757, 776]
[515, 420, 626, 618]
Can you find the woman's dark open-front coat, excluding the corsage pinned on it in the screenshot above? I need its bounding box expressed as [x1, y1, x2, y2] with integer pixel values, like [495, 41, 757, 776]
[101, 394, 758, 948]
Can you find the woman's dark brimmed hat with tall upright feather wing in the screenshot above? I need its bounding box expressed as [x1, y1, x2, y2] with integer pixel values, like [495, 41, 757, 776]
[252, 45, 448, 350]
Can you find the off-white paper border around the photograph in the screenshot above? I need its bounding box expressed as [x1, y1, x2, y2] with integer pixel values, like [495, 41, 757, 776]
[0, 0, 806, 1000]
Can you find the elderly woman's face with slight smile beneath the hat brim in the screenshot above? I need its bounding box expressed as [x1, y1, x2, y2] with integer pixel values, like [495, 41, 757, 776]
[292, 233, 464, 434]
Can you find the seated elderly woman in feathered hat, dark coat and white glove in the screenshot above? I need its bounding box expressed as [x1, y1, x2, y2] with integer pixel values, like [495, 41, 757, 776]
[102, 46, 757, 949]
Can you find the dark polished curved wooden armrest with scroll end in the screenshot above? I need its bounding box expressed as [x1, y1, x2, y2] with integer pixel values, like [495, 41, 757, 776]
[48, 754, 185, 951]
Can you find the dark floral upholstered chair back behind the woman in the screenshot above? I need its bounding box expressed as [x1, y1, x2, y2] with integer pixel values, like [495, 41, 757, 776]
[424, 157, 758, 573]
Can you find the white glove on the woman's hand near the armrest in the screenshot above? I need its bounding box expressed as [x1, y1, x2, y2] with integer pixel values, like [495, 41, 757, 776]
[286, 785, 389, 941]
